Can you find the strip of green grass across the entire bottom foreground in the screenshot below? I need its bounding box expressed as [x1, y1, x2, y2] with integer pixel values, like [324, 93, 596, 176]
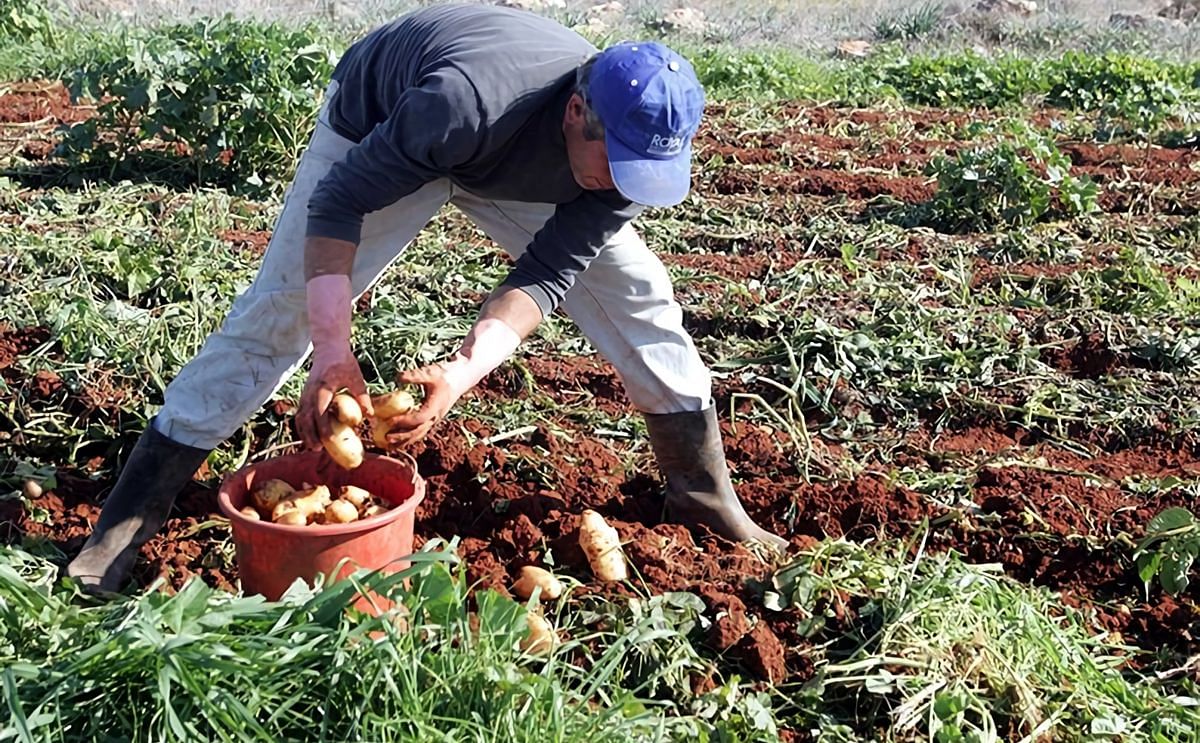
[0, 541, 1200, 742]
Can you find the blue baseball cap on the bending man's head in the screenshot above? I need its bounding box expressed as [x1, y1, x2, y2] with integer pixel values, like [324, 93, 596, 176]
[588, 42, 704, 206]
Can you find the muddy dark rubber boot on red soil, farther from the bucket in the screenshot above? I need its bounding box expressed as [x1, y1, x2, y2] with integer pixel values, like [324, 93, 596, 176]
[646, 406, 787, 550]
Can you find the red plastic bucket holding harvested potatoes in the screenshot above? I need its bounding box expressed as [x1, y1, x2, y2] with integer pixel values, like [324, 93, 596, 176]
[217, 450, 425, 611]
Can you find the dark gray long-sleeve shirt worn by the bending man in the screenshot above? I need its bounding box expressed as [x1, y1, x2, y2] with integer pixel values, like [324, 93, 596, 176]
[307, 5, 642, 316]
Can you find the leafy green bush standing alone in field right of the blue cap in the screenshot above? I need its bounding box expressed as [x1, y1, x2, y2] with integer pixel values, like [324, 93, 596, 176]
[926, 137, 1098, 232]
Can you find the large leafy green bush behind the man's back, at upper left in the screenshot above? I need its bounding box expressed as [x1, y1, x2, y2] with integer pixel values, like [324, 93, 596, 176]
[62, 17, 332, 191]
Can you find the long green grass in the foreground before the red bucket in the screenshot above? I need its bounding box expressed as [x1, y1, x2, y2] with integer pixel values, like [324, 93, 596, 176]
[0, 540, 729, 742]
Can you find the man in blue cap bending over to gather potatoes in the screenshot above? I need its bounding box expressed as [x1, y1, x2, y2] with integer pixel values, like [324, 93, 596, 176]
[68, 5, 786, 591]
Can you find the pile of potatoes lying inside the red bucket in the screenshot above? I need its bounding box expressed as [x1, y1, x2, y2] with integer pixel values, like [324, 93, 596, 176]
[241, 480, 388, 526]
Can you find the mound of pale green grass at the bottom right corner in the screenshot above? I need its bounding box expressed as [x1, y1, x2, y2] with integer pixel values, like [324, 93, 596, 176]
[764, 541, 1200, 743]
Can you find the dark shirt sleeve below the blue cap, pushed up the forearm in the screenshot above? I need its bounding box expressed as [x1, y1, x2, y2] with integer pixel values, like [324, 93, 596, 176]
[504, 191, 644, 317]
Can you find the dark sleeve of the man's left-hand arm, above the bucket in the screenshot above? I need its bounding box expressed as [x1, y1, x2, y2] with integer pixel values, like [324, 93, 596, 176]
[307, 67, 484, 245]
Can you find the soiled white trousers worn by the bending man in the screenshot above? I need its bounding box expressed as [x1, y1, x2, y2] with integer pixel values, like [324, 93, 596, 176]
[155, 88, 712, 449]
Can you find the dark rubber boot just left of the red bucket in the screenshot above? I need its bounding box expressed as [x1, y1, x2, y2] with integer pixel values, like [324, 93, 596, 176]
[67, 421, 209, 593]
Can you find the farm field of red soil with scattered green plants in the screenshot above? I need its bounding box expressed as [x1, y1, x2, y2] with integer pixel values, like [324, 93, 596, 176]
[0, 2, 1200, 742]
